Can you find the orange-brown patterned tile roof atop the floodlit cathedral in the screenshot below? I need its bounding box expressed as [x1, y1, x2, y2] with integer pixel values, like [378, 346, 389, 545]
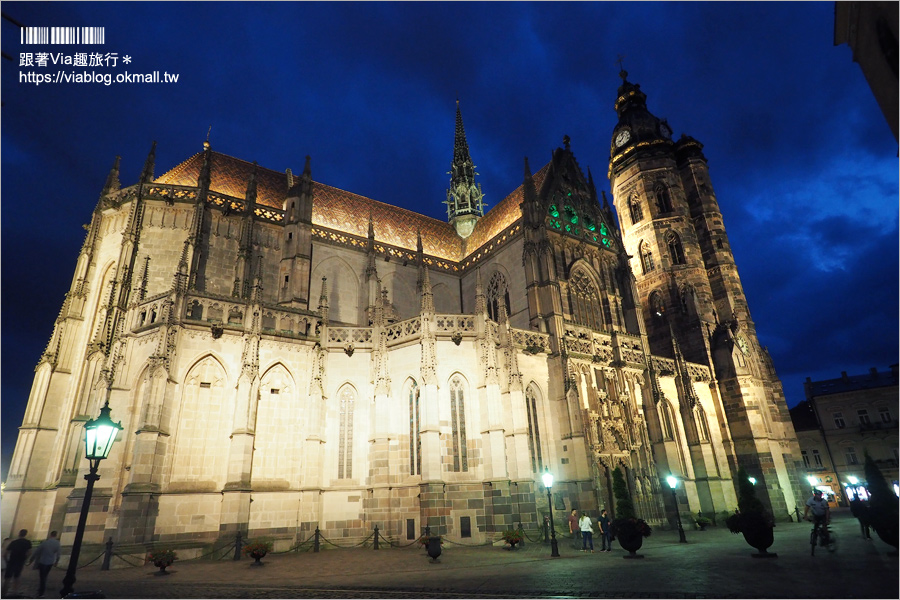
[155, 152, 550, 262]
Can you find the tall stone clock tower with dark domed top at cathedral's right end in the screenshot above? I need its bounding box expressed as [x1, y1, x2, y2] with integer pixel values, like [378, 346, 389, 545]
[609, 71, 801, 513]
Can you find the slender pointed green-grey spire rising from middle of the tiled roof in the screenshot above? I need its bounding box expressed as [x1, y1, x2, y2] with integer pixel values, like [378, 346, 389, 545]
[445, 100, 484, 238]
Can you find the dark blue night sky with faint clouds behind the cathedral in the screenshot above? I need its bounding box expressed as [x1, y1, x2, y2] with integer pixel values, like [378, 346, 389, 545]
[0, 2, 900, 478]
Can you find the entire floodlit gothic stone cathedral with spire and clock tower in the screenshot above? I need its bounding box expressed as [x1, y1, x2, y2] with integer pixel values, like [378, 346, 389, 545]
[2, 72, 802, 558]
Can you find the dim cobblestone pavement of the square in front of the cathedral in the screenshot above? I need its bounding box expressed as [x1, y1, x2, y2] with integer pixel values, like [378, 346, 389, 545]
[8, 511, 900, 598]
